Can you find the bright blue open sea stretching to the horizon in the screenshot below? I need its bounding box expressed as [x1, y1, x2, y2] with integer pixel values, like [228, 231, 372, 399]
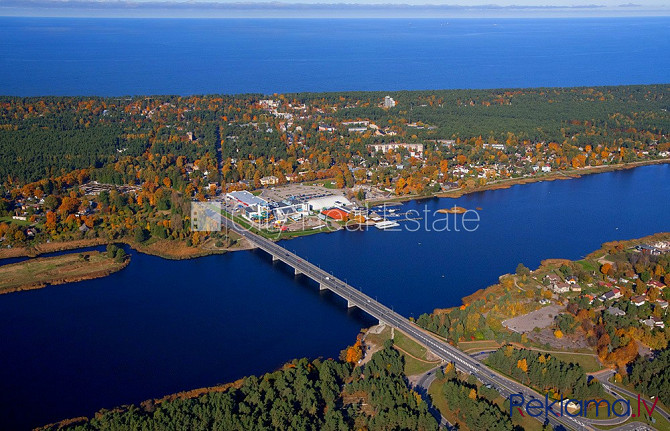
[0, 17, 670, 96]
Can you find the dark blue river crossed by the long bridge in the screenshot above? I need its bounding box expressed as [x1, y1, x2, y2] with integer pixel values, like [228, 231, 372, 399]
[0, 165, 670, 429]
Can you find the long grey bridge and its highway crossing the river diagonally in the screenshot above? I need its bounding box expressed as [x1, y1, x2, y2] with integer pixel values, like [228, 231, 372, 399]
[222, 217, 628, 430]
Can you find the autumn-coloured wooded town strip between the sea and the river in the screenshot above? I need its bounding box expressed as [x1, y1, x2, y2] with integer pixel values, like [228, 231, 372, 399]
[0, 85, 670, 253]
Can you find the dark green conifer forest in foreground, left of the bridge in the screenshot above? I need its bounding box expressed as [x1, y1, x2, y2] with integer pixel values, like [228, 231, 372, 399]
[44, 341, 438, 431]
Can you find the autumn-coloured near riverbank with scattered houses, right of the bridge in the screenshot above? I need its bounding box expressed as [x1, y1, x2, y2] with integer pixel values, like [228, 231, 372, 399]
[417, 232, 670, 356]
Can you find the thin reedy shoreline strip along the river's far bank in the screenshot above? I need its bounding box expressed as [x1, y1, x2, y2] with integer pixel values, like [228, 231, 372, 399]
[0, 158, 670, 264]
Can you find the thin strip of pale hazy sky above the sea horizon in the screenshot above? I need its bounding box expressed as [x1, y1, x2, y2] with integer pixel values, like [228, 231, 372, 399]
[0, 0, 670, 18]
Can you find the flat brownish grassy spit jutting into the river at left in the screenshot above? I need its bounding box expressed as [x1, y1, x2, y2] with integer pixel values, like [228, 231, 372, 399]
[0, 251, 130, 295]
